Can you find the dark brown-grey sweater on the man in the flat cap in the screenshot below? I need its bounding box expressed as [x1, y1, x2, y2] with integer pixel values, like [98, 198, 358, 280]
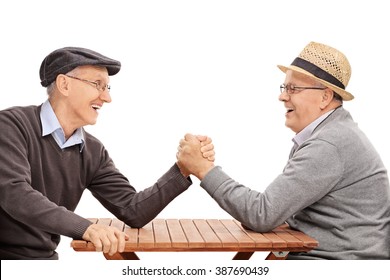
[0, 106, 191, 259]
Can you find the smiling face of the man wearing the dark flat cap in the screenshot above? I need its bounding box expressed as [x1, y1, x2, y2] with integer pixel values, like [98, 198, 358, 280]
[51, 65, 111, 136]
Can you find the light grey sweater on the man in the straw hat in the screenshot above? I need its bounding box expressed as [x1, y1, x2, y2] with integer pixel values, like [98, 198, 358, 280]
[201, 107, 390, 259]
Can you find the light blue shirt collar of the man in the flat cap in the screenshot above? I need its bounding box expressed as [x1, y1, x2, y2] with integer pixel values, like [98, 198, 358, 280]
[41, 100, 85, 153]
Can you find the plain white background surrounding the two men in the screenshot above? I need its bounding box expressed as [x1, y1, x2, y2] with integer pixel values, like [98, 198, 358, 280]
[0, 0, 390, 276]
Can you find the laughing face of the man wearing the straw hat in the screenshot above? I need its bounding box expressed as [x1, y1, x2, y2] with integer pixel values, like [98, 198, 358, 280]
[279, 70, 338, 133]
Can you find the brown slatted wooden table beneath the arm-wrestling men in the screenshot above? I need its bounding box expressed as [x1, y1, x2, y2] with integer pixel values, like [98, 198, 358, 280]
[71, 218, 318, 260]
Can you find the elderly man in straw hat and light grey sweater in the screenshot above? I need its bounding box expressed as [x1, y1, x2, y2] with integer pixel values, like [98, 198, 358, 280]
[177, 42, 390, 259]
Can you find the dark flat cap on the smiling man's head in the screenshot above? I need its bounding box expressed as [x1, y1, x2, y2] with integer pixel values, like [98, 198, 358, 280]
[39, 47, 121, 87]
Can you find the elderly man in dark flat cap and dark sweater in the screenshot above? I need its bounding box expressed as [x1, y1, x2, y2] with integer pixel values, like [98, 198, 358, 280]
[0, 47, 213, 259]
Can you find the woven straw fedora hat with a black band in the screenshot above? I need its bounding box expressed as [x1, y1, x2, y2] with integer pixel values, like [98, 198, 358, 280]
[278, 42, 354, 101]
